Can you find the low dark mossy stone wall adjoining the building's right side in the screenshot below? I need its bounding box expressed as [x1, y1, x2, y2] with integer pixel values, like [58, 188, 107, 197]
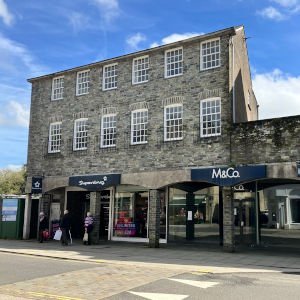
[231, 116, 300, 165]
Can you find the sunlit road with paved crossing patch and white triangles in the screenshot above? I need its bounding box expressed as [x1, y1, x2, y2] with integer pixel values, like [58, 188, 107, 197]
[0, 253, 300, 300]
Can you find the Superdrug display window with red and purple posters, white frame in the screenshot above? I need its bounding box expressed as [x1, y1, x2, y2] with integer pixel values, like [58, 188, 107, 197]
[113, 186, 148, 238]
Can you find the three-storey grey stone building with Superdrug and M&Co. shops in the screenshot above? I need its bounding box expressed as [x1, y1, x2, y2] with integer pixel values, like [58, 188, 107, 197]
[24, 26, 300, 250]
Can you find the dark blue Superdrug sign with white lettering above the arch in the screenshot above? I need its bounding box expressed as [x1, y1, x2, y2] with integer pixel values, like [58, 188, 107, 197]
[69, 174, 121, 191]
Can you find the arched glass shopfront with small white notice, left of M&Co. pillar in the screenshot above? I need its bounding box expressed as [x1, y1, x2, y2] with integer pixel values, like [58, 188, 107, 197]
[168, 182, 223, 245]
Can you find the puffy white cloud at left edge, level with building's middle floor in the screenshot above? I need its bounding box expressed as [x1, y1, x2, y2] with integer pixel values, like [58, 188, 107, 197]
[0, 101, 29, 127]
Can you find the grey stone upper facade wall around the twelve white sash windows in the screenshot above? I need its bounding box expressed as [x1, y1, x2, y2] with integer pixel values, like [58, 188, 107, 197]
[27, 33, 232, 182]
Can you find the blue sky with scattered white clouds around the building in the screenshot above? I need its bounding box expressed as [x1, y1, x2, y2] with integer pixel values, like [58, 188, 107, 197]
[0, 0, 300, 170]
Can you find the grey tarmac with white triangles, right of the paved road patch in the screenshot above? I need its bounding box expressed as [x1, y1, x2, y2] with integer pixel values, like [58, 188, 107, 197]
[106, 273, 300, 300]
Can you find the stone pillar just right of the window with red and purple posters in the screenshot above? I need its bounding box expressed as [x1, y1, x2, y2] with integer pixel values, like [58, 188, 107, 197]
[148, 190, 160, 248]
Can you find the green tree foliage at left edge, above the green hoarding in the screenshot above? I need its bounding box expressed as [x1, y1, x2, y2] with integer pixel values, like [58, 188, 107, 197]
[0, 166, 26, 195]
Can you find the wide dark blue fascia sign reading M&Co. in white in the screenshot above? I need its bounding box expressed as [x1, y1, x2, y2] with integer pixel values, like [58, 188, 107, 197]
[191, 165, 266, 186]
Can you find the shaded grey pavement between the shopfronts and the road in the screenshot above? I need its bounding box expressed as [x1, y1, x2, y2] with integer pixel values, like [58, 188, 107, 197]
[0, 240, 300, 273]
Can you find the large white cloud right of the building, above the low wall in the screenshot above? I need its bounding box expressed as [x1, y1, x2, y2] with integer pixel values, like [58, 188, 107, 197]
[253, 69, 300, 119]
